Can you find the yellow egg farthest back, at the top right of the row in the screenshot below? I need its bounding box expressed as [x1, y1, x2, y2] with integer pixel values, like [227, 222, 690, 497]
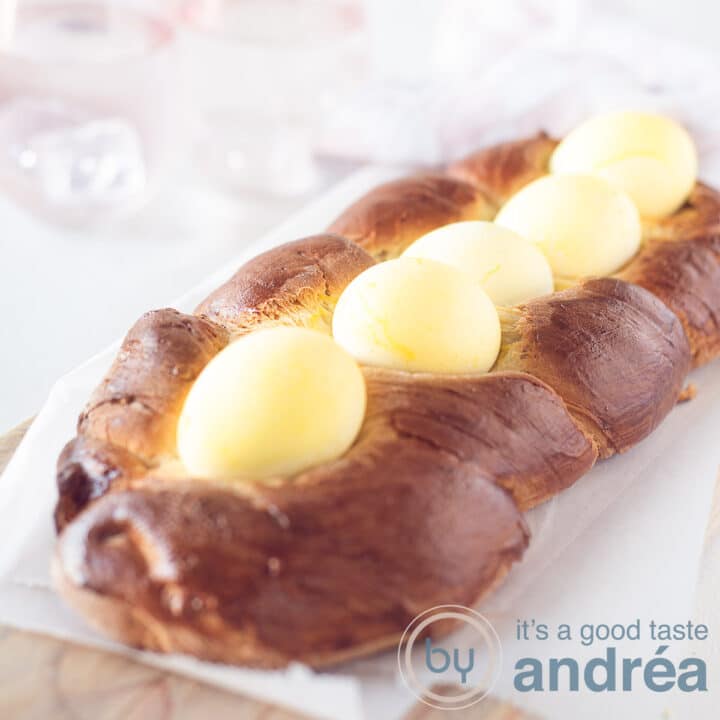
[550, 112, 698, 217]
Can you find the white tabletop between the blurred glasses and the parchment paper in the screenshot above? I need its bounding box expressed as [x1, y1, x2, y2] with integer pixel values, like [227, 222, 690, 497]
[0, 166, 348, 433]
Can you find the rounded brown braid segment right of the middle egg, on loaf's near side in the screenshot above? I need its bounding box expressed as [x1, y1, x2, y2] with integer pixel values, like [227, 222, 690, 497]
[495, 278, 690, 457]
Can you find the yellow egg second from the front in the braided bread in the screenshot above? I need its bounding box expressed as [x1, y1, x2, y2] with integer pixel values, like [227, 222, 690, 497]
[333, 257, 500, 373]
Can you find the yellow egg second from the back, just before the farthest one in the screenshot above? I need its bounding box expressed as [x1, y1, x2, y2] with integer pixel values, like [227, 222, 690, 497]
[495, 175, 640, 280]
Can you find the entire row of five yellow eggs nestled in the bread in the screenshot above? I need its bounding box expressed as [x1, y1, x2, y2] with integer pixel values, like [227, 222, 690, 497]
[177, 112, 697, 480]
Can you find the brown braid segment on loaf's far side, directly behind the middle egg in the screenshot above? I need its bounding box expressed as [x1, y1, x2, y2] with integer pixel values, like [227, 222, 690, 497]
[329, 174, 497, 260]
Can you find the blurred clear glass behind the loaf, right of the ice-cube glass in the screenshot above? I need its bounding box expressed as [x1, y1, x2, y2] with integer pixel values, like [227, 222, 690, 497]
[181, 0, 363, 195]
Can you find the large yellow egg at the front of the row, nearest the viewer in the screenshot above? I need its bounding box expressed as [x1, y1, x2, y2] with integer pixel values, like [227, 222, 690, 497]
[177, 327, 365, 480]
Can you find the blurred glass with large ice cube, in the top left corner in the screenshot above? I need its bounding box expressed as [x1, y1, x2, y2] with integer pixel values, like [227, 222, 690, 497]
[0, 0, 177, 225]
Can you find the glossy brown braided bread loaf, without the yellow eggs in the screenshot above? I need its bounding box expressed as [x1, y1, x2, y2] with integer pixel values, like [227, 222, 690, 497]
[54, 125, 720, 667]
